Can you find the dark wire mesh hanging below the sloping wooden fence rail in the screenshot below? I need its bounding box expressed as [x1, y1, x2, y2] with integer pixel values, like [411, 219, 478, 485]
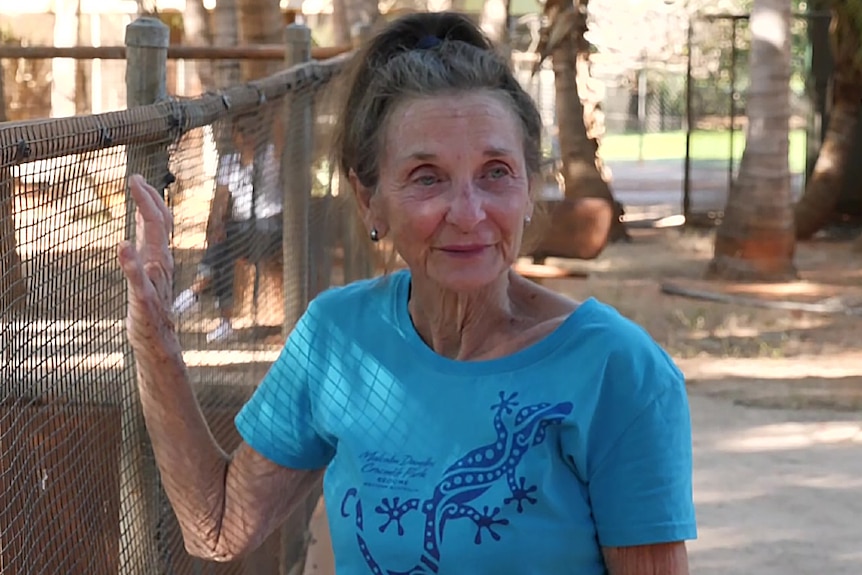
[0, 15, 371, 575]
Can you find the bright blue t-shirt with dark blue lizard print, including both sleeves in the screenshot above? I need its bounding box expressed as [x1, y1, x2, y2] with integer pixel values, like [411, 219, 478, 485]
[236, 271, 696, 575]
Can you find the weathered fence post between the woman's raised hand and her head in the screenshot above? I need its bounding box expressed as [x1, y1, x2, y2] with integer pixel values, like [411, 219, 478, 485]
[281, 24, 313, 337]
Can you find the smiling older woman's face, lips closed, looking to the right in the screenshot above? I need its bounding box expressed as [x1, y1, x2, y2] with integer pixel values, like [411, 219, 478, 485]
[354, 92, 532, 292]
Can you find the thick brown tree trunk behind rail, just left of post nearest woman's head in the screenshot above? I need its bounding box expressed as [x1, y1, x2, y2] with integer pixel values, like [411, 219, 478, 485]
[237, 0, 284, 82]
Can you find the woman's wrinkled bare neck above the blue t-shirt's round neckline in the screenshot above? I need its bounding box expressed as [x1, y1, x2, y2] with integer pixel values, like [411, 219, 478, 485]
[408, 272, 517, 360]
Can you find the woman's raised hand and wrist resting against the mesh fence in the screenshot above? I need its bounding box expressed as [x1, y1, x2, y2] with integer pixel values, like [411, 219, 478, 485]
[117, 175, 178, 357]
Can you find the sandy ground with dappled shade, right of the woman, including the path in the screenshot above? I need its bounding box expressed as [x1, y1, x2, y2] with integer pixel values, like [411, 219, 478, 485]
[306, 229, 862, 575]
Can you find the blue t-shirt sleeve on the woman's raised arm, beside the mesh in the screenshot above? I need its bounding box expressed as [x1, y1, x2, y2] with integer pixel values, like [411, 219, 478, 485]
[235, 303, 335, 469]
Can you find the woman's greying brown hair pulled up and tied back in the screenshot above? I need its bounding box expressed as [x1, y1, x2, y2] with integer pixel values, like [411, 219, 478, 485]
[333, 12, 542, 189]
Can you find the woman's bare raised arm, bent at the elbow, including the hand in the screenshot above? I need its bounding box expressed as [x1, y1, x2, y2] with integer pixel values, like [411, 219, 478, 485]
[118, 176, 322, 561]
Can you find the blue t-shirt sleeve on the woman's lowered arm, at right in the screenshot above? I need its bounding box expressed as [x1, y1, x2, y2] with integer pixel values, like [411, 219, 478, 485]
[588, 356, 697, 547]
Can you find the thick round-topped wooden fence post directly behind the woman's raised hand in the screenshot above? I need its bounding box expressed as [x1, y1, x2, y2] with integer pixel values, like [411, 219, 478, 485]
[120, 17, 170, 575]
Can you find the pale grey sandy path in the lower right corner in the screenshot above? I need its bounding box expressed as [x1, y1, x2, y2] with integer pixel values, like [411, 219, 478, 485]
[689, 393, 862, 575]
